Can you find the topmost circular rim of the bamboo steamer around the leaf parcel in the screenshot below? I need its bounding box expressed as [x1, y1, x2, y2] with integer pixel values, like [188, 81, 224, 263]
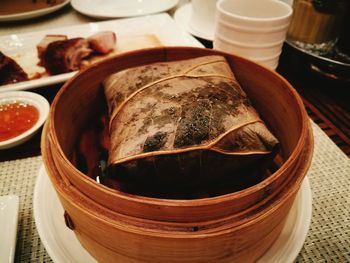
[49, 47, 309, 207]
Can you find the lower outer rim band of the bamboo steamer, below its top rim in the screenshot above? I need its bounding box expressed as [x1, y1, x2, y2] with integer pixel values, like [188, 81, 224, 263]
[42, 120, 314, 239]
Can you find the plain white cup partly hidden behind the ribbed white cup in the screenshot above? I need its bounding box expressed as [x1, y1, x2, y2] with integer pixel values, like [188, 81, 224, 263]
[189, 0, 217, 39]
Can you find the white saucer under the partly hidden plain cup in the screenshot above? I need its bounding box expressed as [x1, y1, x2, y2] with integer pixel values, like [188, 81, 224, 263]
[174, 3, 214, 41]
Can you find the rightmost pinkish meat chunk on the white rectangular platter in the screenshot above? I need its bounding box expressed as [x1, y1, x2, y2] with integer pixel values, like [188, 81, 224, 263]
[87, 31, 117, 54]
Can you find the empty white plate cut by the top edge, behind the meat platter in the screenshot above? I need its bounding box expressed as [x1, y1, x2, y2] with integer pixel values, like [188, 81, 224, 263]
[72, 0, 179, 18]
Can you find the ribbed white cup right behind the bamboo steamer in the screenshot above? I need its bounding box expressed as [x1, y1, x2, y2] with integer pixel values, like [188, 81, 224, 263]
[213, 0, 292, 69]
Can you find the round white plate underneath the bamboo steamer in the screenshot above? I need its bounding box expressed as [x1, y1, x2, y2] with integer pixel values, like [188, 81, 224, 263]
[33, 166, 312, 263]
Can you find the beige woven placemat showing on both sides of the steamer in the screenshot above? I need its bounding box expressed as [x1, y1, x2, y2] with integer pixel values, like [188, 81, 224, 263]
[0, 124, 350, 262]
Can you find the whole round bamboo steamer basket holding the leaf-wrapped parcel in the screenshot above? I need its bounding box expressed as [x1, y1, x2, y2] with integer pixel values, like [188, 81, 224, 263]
[42, 47, 313, 262]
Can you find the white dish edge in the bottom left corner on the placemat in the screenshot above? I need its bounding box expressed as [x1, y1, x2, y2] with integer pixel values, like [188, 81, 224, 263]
[0, 195, 19, 263]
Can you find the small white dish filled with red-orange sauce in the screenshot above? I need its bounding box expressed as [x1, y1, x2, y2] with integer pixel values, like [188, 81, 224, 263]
[0, 91, 50, 150]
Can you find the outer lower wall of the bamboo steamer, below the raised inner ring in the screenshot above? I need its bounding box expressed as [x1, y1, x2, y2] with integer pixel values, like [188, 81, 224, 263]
[42, 123, 313, 262]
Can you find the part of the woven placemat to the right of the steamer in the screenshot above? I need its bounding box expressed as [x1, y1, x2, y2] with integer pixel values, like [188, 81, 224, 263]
[296, 123, 350, 262]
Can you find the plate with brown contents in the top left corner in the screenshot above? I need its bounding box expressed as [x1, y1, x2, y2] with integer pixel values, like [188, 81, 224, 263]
[0, 0, 70, 22]
